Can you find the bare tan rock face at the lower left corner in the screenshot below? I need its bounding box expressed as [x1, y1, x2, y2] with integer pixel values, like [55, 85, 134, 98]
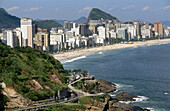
[2, 83, 32, 108]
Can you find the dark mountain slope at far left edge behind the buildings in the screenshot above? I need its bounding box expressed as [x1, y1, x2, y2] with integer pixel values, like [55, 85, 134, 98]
[0, 8, 20, 30]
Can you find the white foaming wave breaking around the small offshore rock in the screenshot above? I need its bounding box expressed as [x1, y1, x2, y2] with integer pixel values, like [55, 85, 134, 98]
[119, 96, 149, 104]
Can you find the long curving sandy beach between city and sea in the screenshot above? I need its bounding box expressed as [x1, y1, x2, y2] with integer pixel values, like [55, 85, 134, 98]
[52, 39, 170, 61]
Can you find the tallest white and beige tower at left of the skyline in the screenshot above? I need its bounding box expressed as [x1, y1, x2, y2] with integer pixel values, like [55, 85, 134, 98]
[21, 18, 33, 47]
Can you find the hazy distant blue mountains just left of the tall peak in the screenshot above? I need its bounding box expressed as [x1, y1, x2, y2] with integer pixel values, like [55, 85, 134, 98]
[54, 17, 87, 25]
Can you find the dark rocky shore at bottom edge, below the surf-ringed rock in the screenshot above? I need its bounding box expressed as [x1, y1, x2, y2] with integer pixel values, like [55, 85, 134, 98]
[108, 101, 145, 111]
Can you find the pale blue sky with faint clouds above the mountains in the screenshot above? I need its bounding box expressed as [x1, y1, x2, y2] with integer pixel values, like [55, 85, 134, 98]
[0, 0, 170, 22]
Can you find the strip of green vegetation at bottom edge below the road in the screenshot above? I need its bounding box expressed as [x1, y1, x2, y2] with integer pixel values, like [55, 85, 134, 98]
[43, 103, 86, 111]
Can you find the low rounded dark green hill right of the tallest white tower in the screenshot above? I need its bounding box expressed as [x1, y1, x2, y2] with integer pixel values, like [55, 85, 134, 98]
[34, 20, 62, 30]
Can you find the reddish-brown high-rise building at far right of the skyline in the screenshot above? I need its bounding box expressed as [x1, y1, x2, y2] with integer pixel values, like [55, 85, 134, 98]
[154, 22, 164, 37]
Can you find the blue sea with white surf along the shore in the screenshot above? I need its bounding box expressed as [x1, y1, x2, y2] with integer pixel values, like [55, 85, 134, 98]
[61, 43, 170, 111]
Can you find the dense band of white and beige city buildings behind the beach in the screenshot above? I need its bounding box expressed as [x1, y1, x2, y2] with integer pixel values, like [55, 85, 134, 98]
[0, 18, 170, 52]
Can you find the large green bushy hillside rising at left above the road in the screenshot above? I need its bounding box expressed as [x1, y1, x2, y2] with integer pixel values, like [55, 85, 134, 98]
[0, 41, 68, 100]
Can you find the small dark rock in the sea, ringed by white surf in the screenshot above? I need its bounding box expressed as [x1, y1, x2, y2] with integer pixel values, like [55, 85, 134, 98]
[116, 91, 136, 101]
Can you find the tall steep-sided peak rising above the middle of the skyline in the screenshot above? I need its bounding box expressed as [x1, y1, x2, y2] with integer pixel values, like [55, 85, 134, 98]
[88, 8, 118, 21]
